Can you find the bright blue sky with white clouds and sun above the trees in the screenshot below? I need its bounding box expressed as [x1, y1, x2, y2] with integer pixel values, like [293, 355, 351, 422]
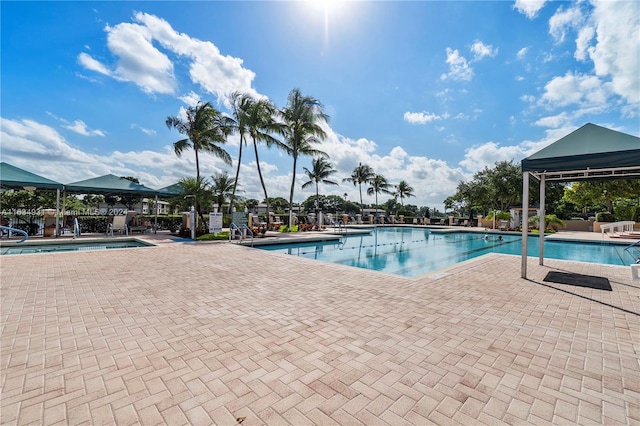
[0, 0, 640, 209]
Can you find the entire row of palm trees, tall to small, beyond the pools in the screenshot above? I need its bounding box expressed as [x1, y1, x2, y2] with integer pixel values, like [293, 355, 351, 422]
[165, 89, 422, 223]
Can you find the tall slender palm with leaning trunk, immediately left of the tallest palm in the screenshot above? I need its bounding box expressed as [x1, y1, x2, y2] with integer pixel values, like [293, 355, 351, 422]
[247, 99, 287, 217]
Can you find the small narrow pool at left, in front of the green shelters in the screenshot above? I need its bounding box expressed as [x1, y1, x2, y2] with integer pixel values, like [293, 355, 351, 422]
[0, 240, 153, 255]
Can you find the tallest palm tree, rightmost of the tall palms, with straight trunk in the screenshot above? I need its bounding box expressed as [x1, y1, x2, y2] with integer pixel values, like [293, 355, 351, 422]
[281, 89, 329, 224]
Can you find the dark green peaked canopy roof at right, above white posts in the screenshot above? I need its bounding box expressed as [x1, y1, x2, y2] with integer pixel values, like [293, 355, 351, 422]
[522, 123, 640, 181]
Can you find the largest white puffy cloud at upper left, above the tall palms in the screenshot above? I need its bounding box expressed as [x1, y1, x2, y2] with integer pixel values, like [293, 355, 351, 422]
[78, 12, 259, 100]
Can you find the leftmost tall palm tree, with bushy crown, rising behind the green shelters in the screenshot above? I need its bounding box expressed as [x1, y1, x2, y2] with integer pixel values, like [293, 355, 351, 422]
[165, 102, 233, 179]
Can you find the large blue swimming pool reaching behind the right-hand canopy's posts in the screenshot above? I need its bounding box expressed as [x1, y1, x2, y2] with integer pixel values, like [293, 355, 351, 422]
[259, 227, 635, 277]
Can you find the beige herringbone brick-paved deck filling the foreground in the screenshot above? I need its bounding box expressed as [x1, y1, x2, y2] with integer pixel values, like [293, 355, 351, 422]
[0, 238, 640, 426]
